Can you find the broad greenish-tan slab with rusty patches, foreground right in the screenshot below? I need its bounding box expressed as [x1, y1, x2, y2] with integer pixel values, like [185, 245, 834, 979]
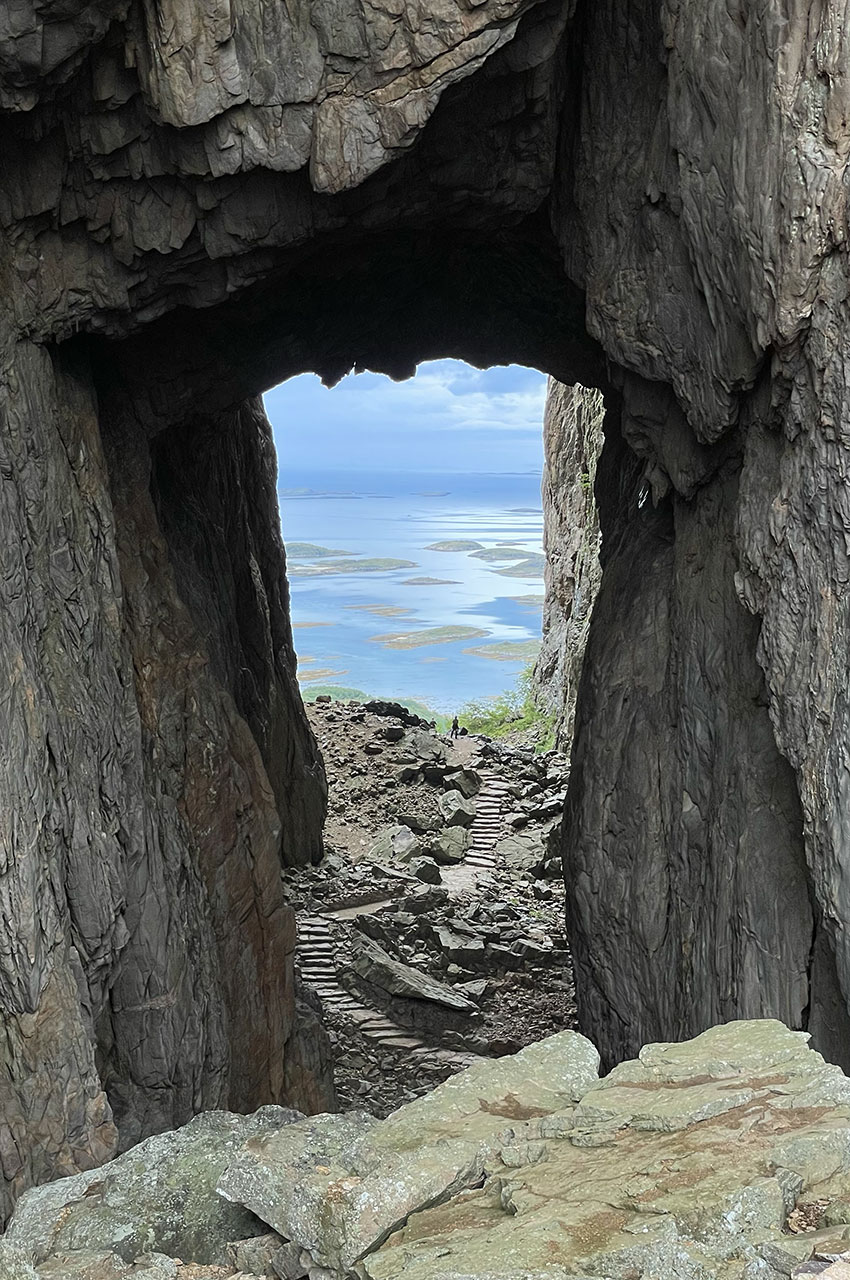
[357, 1021, 850, 1280]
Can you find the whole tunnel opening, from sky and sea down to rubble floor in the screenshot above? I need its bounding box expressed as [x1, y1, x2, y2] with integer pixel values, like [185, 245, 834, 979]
[265, 360, 590, 1114]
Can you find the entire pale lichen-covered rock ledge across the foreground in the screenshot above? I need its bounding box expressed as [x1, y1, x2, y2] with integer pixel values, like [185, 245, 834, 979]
[8, 1021, 850, 1280]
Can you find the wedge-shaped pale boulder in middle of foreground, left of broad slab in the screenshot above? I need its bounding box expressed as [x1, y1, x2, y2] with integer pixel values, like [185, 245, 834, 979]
[219, 1032, 599, 1276]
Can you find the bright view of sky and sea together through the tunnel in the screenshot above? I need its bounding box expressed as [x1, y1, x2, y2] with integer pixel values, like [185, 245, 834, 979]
[265, 360, 554, 727]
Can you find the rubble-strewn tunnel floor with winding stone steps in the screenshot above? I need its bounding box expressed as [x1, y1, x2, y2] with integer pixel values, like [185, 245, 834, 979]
[288, 703, 575, 1115]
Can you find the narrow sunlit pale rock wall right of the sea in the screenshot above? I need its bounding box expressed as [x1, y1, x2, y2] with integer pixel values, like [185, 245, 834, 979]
[534, 378, 604, 754]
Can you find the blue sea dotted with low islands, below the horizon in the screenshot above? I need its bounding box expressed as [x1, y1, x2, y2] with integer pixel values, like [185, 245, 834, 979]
[279, 470, 543, 713]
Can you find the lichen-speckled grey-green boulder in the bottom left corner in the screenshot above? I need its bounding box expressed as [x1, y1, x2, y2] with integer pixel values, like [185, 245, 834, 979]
[4, 1107, 300, 1266]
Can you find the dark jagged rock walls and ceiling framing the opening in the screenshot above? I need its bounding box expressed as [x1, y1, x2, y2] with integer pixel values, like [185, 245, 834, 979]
[0, 0, 850, 1223]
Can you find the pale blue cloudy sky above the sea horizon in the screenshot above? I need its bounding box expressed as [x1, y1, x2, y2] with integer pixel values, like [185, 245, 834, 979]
[265, 360, 547, 485]
